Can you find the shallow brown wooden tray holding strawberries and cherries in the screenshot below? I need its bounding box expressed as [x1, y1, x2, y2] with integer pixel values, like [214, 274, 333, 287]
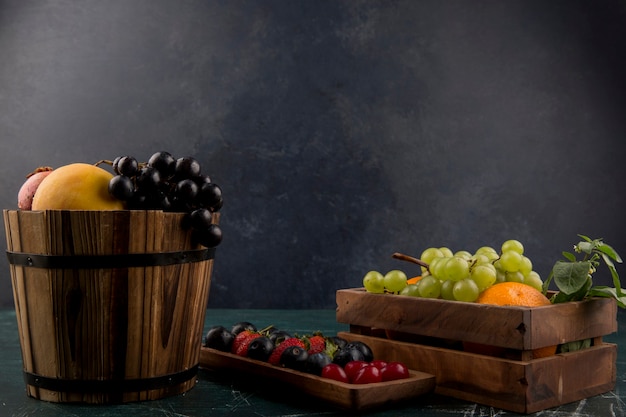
[200, 347, 435, 410]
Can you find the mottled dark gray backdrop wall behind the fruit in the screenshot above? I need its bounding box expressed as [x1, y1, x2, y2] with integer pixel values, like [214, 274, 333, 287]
[0, 0, 626, 308]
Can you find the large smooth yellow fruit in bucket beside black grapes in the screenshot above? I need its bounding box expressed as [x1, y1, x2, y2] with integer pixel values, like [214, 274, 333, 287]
[32, 163, 124, 210]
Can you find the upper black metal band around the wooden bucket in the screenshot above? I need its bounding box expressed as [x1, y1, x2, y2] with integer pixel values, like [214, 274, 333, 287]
[7, 248, 215, 269]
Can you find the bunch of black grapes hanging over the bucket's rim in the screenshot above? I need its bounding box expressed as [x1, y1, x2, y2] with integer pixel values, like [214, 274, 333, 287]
[109, 151, 223, 248]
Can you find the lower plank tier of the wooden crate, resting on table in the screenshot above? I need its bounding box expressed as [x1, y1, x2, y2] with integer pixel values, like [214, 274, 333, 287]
[338, 332, 617, 413]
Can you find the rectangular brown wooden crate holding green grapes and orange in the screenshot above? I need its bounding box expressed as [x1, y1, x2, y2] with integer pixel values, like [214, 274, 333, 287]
[336, 288, 617, 413]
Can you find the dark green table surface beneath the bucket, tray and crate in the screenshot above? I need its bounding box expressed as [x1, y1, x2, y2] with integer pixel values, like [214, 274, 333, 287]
[0, 309, 626, 417]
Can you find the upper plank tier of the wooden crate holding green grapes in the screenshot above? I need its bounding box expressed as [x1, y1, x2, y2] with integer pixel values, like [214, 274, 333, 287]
[336, 288, 617, 350]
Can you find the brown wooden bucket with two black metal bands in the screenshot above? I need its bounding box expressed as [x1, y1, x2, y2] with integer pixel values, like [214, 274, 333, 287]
[3, 210, 218, 404]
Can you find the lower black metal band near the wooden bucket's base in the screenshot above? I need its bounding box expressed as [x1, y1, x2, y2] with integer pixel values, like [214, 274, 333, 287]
[24, 365, 198, 393]
